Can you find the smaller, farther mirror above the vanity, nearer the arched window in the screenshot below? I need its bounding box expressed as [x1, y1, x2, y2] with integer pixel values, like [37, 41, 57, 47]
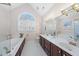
[45, 19, 56, 34]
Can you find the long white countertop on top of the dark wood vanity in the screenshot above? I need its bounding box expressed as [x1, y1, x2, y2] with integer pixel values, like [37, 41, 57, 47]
[40, 34, 79, 56]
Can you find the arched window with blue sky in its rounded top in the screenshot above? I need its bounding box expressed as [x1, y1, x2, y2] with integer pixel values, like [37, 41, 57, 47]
[18, 12, 35, 32]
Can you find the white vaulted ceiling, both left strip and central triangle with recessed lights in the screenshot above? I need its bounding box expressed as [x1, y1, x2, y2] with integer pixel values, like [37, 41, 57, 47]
[0, 3, 54, 16]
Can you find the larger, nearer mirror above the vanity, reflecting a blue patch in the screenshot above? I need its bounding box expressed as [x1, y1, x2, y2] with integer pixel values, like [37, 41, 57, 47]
[56, 15, 74, 38]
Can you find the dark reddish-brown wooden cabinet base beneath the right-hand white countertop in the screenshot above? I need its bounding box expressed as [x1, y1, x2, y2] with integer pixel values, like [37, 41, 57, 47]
[39, 36, 72, 56]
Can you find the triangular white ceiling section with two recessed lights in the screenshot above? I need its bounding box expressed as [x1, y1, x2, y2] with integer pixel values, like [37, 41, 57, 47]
[30, 3, 55, 16]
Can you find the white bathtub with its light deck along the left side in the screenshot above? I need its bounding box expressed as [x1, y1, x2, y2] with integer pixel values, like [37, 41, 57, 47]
[0, 37, 24, 56]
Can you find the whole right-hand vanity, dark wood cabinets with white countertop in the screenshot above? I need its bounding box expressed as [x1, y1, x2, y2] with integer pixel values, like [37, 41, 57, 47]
[39, 35, 79, 56]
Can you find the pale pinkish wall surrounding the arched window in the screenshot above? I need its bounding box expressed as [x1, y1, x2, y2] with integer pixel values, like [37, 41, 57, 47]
[11, 4, 41, 39]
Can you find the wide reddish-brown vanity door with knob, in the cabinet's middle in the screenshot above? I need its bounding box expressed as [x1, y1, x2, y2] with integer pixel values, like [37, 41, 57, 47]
[51, 44, 62, 56]
